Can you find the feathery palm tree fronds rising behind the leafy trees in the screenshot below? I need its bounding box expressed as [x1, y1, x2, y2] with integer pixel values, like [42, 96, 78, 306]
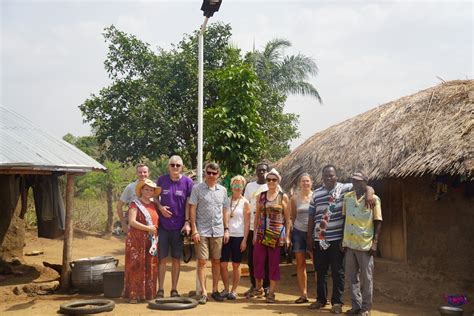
[252, 38, 322, 103]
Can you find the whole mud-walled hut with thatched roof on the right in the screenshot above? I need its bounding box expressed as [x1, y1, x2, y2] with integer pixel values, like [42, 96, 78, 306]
[277, 80, 474, 289]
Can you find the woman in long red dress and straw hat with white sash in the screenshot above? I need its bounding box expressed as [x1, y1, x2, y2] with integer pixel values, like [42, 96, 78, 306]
[123, 179, 161, 303]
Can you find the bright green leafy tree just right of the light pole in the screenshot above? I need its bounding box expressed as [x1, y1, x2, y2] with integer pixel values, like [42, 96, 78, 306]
[204, 62, 264, 175]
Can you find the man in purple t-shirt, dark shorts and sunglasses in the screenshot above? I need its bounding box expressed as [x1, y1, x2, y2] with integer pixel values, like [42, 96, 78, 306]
[156, 156, 193, 298]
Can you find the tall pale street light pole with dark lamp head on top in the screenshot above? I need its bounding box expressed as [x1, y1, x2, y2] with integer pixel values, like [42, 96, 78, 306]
[196, 0, 222, 183]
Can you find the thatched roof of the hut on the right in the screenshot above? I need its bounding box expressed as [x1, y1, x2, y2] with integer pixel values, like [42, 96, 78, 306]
[277, 80, 474, 189]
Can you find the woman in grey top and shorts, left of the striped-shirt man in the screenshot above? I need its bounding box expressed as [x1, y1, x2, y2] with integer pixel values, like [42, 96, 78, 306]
[290, 173, 313, 304]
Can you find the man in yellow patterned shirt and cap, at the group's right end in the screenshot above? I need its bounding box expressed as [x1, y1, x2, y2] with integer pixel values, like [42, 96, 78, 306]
[342, 172, 382, 316]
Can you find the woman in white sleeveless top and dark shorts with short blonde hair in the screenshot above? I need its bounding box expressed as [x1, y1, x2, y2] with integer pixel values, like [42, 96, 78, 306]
[221, 175, 250, 300]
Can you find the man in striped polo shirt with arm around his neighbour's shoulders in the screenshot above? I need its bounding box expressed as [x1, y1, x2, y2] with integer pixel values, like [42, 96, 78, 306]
[307, 165, 374, 314]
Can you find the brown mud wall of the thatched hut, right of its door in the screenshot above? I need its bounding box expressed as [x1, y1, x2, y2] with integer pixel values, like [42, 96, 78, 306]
[404, 176, 474, 283]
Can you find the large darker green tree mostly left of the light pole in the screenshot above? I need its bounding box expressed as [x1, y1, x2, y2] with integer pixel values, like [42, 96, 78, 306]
[79, 24, 234, 166]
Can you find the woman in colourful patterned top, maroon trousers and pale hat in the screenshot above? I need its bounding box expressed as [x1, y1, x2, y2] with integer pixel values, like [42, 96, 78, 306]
[250, 169, 291, 303]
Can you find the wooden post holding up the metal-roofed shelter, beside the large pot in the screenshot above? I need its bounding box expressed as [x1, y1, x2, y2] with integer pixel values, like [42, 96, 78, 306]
[61, 173, 75, 291]
